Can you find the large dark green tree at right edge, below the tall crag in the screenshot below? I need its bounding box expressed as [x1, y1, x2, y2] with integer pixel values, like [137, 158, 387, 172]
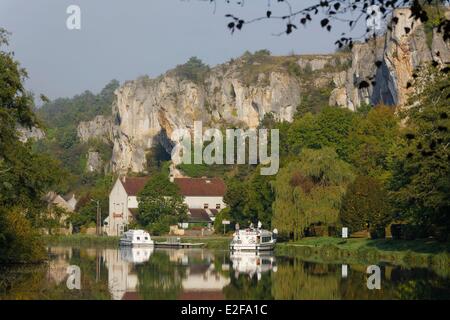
[390, 65, 450, 240]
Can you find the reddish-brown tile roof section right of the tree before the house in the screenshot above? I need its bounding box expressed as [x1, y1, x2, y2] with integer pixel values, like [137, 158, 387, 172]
[174, 178, 226, 197]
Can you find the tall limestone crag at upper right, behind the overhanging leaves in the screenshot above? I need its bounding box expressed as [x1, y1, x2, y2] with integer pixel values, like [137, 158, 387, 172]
[336, 8, 450, 110]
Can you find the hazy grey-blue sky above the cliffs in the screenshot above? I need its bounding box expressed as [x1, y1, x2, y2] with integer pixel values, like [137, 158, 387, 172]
[0, 0, 358, 98]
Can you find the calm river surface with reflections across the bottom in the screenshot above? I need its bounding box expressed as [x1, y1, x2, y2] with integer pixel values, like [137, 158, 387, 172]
[0, 247, 450, 300]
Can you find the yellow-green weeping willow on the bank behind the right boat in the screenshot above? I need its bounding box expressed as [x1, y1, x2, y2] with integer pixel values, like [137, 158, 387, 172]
[272, 148, 354, 239]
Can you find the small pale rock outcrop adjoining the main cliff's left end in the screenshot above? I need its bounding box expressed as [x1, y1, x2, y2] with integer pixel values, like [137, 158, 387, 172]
[77, 116, 113, 142]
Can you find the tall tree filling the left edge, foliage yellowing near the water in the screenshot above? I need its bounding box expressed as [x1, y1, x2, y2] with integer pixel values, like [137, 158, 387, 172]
[0, 29, 64, 262]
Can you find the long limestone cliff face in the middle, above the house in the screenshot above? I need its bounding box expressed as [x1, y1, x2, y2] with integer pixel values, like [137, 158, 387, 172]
[111, 63, 300, 172]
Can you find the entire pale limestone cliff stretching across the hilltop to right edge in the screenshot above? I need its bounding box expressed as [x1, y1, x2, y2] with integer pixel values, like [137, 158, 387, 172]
[78, 9, 450, 172]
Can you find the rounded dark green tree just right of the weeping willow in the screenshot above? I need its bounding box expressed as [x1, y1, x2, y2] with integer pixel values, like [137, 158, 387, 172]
[340, 176, 392, 238]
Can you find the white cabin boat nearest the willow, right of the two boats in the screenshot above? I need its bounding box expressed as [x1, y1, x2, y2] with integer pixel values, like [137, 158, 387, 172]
[230, 227, 277, 251]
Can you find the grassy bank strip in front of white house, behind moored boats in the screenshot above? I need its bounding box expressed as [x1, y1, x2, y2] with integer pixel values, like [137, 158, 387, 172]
[43, 234, 231, 249]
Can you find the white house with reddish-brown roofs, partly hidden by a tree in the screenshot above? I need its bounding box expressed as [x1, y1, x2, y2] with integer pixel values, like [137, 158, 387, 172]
[104, 177, 226, 236]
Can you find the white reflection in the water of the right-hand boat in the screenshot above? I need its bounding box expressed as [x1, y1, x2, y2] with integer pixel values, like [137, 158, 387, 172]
[230, 252, 277, 279]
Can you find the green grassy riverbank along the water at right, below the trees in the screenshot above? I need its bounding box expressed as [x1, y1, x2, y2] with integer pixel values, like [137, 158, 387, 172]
[275, 237, 450, 277]
